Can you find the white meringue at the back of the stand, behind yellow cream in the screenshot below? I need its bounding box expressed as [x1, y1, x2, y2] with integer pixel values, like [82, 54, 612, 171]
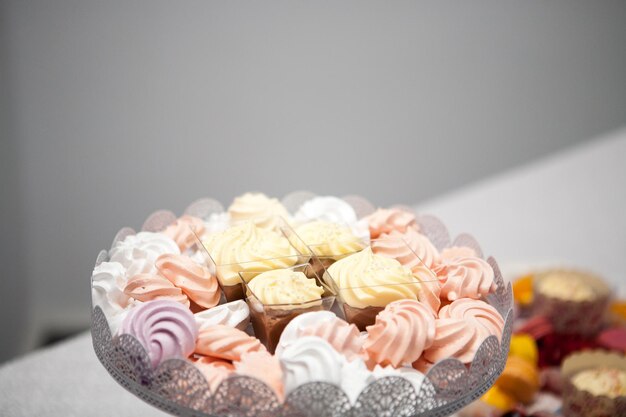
[294, 196, 358, 225]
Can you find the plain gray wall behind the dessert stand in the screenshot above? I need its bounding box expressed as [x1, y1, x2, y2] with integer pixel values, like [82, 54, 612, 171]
[0, 0, 626, 358]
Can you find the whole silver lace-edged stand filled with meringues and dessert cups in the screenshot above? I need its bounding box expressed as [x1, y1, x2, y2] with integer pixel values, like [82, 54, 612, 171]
[91, 192, 513, 417]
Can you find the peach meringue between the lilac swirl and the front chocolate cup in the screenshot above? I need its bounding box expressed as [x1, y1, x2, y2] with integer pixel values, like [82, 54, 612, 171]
[196, 324, 266, 361]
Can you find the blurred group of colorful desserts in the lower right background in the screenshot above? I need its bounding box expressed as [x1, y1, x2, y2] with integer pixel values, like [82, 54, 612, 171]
[457, 262, 626, 417]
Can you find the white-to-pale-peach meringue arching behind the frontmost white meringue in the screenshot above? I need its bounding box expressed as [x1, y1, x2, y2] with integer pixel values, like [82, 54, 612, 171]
[276, 311, 364, 360]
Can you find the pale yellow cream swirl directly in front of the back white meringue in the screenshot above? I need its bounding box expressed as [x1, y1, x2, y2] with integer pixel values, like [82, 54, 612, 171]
[295, 220, 365, 259]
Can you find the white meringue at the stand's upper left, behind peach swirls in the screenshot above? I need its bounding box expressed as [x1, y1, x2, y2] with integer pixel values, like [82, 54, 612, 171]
[109, 232, 180, 277]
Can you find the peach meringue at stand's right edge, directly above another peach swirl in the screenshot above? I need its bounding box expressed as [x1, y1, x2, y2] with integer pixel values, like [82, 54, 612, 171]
[435, 258, 494, 301]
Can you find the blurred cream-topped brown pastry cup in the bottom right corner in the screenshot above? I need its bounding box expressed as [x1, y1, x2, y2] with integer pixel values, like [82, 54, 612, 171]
[561, 350, 626, 417]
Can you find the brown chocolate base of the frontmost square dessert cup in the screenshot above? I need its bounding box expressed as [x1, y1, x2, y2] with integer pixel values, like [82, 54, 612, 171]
[250, 303, 324, 354]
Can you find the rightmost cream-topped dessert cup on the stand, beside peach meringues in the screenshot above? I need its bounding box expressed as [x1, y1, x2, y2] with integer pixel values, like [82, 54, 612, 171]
[324, 247, 437, 331]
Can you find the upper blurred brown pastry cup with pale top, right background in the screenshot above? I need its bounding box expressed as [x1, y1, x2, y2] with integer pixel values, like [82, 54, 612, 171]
[533, 269, 611, 336]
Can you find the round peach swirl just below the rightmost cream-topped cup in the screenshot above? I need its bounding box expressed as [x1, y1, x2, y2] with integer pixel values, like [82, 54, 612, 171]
[363, 300, 435, 368]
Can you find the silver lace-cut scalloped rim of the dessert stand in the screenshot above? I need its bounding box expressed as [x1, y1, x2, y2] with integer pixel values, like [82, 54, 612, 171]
[91, 191, 513, 417]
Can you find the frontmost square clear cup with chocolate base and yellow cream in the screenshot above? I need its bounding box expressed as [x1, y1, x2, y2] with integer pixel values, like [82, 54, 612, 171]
[239, 263, 335, 353]
